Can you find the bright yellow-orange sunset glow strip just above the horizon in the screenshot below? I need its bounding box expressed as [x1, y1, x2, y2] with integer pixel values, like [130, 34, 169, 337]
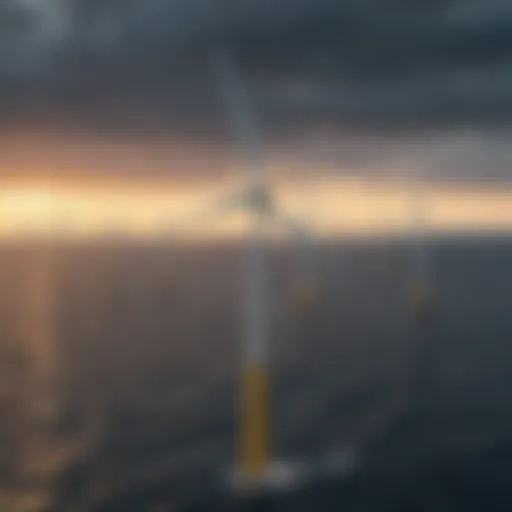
[0, 177, 512, 239]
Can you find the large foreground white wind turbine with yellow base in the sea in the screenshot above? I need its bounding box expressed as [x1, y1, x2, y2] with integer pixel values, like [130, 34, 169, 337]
[165, 49, 317, 492]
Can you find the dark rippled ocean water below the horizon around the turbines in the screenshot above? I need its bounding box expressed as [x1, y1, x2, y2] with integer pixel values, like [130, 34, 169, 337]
[0, 237, 512, 512]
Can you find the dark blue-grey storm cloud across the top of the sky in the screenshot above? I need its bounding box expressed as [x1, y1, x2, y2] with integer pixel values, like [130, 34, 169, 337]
[4, 0, 512, 132]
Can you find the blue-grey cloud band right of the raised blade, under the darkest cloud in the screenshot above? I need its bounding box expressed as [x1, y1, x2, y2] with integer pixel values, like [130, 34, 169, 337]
[259, 60, 512, 128]
